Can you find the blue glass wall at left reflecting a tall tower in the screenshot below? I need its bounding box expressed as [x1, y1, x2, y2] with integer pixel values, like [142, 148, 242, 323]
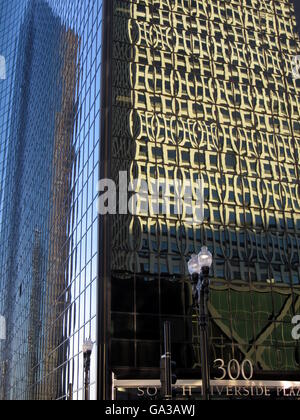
[0, 0, 102, 400]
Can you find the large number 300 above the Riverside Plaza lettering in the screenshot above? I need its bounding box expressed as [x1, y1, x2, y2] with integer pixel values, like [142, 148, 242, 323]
[214, 359, 254, 381]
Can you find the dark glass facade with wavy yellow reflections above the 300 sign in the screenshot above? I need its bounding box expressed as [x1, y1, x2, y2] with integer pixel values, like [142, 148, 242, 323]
[112, 0, 300, 374]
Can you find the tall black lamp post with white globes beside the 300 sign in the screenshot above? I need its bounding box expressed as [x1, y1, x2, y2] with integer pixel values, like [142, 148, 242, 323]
[188, 246, 213, 400]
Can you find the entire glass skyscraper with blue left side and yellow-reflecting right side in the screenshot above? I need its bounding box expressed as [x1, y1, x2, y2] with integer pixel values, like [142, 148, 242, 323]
[0, 0, 300, 399]
